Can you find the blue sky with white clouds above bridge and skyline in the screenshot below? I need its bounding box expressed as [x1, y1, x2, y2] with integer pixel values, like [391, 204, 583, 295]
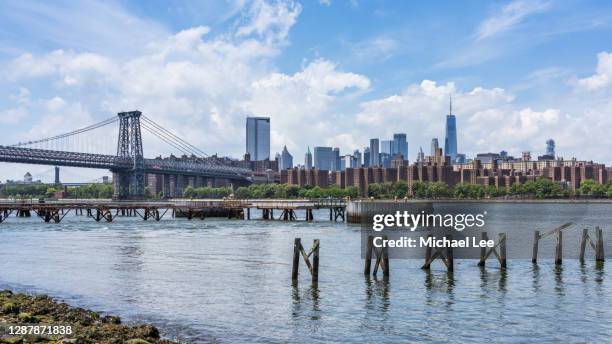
[0, 0, 612, 182]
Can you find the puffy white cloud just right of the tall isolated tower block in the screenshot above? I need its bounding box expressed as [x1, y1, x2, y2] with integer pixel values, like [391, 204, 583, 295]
[244, 59, 370, 156]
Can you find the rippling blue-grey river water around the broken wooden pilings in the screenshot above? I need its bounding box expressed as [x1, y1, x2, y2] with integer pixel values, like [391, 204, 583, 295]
[0, 204, 612, 343]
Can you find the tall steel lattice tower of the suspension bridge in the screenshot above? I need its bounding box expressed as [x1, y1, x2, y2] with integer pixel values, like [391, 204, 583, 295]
[113, 111, 145, 199]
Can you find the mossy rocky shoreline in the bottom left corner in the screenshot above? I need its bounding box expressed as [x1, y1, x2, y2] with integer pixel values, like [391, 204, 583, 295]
[0, 290, 178, 344]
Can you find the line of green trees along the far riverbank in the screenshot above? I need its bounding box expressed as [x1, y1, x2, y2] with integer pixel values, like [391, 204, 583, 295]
[0, 177, 612, 199]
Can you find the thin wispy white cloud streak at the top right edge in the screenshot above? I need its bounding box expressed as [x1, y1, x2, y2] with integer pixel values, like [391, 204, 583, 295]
[475, 0, 550, 40]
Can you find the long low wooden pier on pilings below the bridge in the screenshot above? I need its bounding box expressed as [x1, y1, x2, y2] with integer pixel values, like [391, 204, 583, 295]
[0, 199, 346, 223]
